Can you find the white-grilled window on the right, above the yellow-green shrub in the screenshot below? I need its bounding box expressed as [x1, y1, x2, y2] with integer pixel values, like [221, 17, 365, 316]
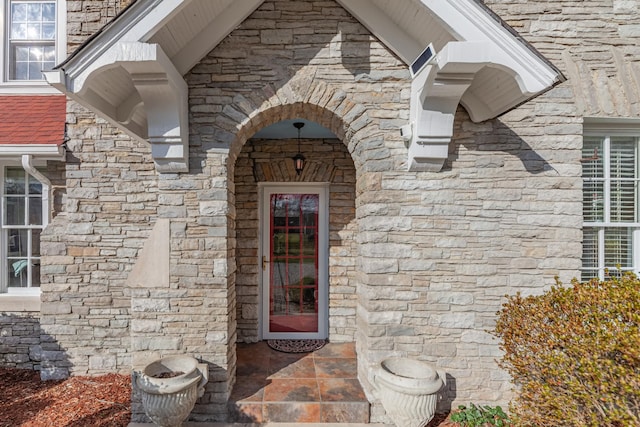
[581, 129, 640, 280]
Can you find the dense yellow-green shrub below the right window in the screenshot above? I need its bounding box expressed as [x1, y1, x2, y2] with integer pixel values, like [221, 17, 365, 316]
[495, 274, 640, 427]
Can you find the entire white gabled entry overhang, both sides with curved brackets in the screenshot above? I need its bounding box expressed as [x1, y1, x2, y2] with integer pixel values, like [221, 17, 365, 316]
[46, 0, 563, 172]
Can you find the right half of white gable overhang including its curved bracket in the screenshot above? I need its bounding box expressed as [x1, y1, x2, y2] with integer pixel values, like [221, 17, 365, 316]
[338, 0, 563, 172]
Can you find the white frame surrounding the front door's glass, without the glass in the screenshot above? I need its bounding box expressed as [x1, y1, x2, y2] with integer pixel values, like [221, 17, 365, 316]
[257, 182, 329, 339]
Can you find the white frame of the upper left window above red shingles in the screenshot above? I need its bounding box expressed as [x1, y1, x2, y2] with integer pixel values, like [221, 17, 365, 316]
[0, 0, 67, 95]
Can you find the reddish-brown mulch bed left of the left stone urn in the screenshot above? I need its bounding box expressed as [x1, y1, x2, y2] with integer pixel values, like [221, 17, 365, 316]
[0, 368, 131, 427]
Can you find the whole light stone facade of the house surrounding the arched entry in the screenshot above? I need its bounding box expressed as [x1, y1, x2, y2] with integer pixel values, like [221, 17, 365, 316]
[3, 0, 640, 421]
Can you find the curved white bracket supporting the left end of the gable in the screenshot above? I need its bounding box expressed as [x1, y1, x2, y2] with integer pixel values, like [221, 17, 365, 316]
[45, 42, 189, 172]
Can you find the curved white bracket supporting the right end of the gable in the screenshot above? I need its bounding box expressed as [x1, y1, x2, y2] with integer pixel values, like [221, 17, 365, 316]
[403, 41, 557, 172]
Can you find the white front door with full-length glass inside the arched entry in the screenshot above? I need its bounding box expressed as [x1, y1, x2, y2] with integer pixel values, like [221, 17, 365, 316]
[260, 184, 329, 339]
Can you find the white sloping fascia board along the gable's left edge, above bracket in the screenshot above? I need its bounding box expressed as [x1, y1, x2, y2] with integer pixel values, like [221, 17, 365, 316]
[60, 0, 194, 84]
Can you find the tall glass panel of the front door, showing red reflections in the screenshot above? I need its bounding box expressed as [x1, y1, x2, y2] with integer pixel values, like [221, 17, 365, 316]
[269, 193, 320, 333]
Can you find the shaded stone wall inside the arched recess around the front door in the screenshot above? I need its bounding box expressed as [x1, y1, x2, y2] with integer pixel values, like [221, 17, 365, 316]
[234, 139, 357, 342]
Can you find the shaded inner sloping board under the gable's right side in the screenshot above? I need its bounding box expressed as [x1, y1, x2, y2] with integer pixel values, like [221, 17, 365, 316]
[337, 0, 422, 65]
